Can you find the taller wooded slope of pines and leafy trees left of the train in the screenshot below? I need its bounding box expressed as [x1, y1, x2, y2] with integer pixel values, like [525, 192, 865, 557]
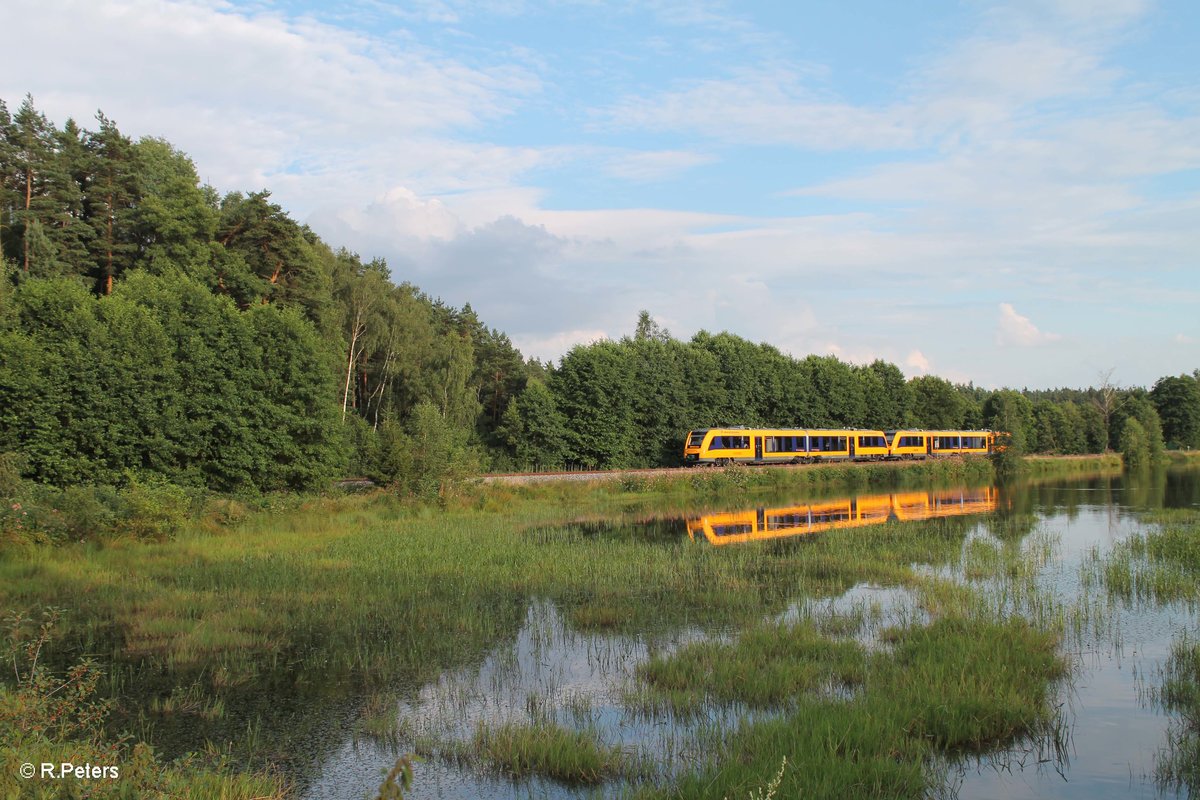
[0, 97, 541, 491]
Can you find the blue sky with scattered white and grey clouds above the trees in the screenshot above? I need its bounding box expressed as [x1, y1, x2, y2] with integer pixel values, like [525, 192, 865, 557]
[0, 0, 1200, 389]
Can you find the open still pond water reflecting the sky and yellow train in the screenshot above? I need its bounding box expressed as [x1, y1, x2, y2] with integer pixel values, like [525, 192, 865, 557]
[302, 470, 1200, 800]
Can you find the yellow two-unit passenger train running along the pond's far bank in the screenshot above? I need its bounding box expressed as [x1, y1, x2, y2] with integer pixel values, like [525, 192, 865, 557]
[683, 428, 996, 467]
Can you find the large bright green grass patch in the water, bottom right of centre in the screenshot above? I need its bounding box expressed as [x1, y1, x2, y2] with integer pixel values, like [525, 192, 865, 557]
[637, 606, 1068, 799]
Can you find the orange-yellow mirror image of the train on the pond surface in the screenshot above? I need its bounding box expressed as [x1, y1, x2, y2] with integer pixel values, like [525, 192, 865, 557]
[688, 486, 996, 545]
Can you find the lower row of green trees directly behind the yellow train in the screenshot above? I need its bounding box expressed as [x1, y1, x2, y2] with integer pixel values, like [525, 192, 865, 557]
[500, 312, 1200, 468]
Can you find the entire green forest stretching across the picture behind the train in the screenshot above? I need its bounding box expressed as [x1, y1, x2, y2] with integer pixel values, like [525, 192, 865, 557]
[0, 96, 1200, 506]
